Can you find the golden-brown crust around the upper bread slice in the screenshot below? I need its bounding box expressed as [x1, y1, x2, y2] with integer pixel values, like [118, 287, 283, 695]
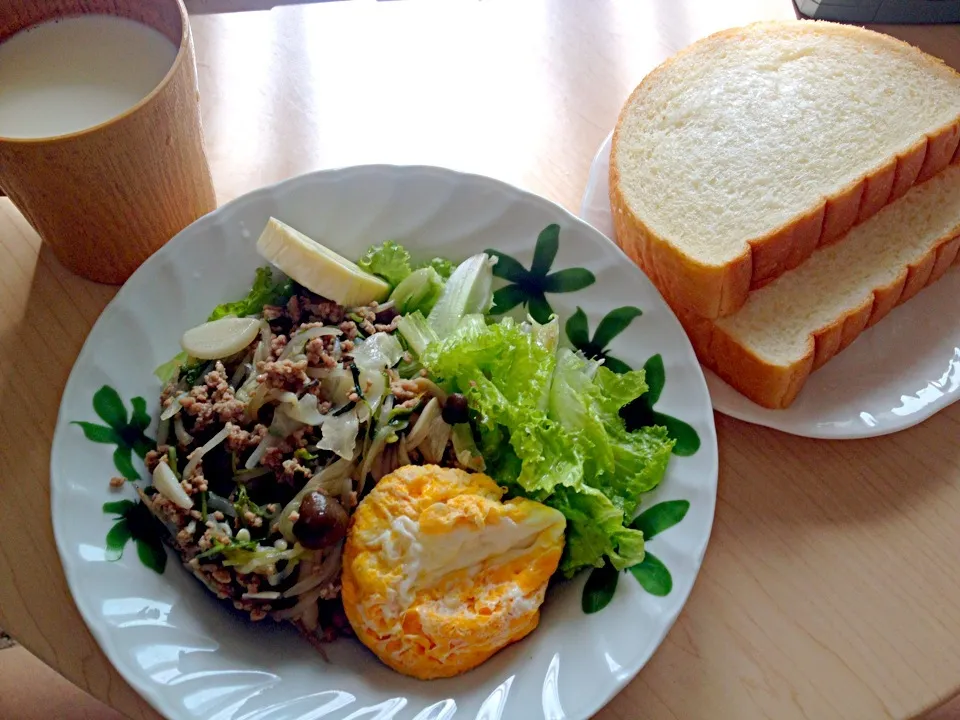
[610, 20, 960, 319]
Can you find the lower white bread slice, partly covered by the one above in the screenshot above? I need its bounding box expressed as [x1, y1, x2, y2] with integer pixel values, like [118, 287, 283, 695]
[680, 165, 960, 408]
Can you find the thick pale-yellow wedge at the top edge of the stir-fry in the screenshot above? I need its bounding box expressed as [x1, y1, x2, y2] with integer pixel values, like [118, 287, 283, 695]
[257, 218, 390, 307]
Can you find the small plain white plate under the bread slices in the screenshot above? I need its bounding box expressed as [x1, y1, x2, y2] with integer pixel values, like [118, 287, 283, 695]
[580, 133, 960, 439]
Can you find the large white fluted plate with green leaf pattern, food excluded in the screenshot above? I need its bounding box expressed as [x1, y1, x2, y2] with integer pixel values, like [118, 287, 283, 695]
[51, 166, 717, 720]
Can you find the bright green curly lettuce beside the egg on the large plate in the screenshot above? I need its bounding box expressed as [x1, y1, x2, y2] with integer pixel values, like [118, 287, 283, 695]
[422, 315, 673, 576]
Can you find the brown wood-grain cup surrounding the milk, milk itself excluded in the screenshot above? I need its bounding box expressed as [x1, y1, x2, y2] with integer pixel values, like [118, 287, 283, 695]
[0, 0, 217, 284]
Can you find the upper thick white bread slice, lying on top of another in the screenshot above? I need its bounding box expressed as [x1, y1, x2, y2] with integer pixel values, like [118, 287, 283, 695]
[610, 21, 960, 318]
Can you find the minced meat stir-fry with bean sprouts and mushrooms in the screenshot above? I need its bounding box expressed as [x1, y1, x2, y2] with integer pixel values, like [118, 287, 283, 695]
[139, 284, 482, 641]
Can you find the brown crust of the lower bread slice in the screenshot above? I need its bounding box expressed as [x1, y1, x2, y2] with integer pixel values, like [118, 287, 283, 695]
[674, 231, 960, 409]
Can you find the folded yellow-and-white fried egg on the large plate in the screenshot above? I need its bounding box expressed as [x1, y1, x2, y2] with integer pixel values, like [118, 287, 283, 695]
[342, 465, 566, 680]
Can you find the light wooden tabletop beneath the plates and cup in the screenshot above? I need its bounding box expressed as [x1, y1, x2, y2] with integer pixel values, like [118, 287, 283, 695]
[0, 0, 960, 720]
